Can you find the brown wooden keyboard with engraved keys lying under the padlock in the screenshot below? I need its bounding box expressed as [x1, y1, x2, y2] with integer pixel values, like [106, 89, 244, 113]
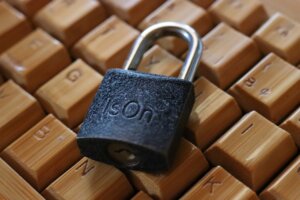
[0, 0, 300, 200]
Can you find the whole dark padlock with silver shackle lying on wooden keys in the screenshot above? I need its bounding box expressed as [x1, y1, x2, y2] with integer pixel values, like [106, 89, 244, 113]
[77, 22, 202, 171]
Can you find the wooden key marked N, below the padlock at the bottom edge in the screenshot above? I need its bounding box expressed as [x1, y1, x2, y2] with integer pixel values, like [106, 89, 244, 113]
[43, 157, 133, 200]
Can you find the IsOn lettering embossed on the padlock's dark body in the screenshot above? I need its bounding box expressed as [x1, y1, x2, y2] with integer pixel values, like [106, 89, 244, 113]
[103, 99, 155, 123]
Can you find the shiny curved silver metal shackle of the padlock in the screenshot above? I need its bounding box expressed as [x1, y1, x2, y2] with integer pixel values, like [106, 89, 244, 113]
[124, 22, 202, 82]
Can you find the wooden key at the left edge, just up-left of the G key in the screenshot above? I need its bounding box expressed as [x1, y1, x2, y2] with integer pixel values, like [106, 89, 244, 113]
[0, 29, 71, 92]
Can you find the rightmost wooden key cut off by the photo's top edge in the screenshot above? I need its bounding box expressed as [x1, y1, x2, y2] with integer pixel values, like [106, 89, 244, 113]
[209, 0, 268, 35]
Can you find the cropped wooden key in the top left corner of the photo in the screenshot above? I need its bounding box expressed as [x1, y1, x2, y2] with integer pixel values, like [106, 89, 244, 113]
[0, 2, 32, 54]
